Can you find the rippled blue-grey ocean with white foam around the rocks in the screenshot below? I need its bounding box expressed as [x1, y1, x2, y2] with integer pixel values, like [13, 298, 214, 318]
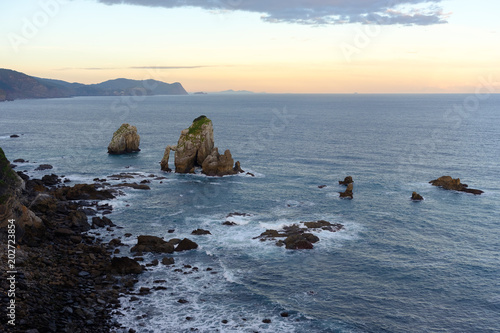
[0, 94, 500, 333]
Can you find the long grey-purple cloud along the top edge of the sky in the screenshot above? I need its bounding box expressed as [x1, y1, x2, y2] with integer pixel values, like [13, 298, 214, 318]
[97, 0, 448, 25]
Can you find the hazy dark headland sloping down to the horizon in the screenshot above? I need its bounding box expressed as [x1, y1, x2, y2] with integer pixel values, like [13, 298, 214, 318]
[0, 69, 188, 102]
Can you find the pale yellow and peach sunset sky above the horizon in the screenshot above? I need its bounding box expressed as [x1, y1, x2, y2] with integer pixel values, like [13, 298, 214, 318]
[0, 0, 500, 93]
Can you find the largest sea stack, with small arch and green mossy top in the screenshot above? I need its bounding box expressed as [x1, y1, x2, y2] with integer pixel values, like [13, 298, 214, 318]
[166, 116, 244, 176]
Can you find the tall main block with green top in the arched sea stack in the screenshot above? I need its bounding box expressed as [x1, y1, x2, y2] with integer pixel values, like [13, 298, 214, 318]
[175, 116, 214, 173]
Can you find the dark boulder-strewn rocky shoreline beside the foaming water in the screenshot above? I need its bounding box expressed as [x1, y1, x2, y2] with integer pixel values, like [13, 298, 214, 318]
[0, 149, 143, 333]
